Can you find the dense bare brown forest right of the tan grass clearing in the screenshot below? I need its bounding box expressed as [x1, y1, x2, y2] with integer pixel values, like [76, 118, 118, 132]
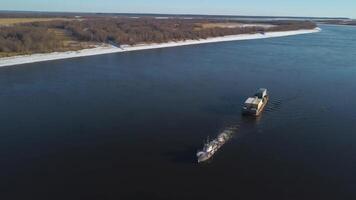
[33, 18, 316, 45]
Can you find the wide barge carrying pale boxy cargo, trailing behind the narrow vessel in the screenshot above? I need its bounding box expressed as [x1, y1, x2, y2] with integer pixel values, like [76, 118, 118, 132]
[242, 88, 269, 117]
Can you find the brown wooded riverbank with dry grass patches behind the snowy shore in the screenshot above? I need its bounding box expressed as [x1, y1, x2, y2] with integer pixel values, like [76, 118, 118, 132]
[0, 17, 316, 56]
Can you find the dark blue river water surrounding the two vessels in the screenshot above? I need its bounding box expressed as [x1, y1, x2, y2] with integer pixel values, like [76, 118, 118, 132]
[0, 26, 356, 200]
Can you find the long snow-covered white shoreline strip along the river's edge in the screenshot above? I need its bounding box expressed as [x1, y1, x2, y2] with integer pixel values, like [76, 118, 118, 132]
[0, 28, 321, 67]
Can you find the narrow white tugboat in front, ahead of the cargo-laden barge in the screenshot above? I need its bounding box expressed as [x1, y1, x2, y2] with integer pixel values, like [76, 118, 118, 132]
[197, 128, 237, 163]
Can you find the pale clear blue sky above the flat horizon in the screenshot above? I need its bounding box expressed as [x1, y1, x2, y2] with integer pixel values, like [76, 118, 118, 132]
[0, 0, 356, 18]
